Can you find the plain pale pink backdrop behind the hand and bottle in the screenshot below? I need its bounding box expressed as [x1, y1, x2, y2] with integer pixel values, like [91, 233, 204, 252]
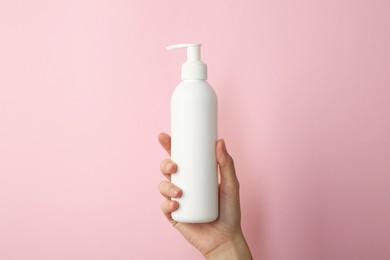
[0, 0, 390, 260]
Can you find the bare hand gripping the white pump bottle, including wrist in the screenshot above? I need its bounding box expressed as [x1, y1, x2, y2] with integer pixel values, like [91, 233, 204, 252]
[158, 133, 252, 260]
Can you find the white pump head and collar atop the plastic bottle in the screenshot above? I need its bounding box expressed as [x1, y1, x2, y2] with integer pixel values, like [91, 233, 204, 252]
[167, 43, 207, 80]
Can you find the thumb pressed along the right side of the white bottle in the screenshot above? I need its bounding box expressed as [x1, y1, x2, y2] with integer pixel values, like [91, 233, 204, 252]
[216, 139, 239, 192]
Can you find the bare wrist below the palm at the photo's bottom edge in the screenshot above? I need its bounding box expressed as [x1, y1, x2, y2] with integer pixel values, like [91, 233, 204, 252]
[205, 232, 253, 260]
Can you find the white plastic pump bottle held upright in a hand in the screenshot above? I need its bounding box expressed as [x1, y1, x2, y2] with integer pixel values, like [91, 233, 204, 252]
[167, 44, 218, 223]
